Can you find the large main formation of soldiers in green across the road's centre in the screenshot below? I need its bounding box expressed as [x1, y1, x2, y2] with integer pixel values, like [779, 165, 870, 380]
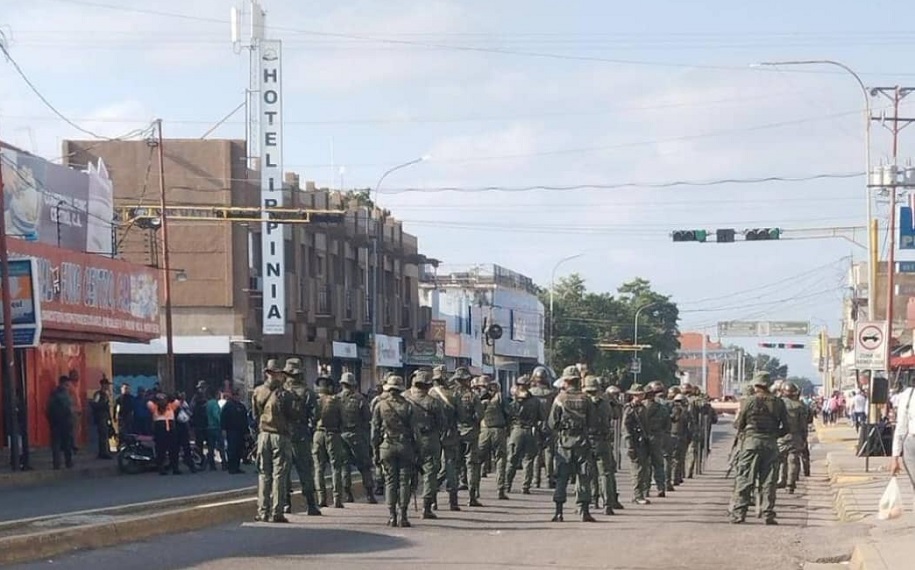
[252, 358, 728, 527]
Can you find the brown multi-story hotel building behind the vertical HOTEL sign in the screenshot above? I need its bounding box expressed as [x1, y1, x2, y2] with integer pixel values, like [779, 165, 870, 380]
[64, 140, 436, 390]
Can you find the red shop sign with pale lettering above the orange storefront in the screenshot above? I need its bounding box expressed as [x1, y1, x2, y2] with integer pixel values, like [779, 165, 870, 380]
[9, 240, 160, 342]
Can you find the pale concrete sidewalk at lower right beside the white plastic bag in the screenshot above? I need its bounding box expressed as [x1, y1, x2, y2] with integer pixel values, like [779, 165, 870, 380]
[816, 423, 915, 570]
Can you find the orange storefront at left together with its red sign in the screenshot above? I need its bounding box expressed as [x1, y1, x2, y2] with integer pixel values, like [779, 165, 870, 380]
[0, 239, 160, 447]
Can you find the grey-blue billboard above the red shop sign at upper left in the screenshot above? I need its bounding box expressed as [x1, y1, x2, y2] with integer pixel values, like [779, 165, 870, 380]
[0, 148, 114, 255]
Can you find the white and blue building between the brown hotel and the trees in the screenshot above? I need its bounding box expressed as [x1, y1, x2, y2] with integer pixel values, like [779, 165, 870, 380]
[420, 265, 544, 389]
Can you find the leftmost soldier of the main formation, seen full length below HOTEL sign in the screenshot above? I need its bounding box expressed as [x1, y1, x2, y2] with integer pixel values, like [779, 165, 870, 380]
[252, 359, 291, 523]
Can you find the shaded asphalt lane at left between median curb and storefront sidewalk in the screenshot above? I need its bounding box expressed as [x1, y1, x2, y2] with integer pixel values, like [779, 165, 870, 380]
[0, 466, 257, 521]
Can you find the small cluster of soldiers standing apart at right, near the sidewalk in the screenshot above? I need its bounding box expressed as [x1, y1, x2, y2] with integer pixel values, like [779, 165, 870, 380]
[728, 372, 813, 525]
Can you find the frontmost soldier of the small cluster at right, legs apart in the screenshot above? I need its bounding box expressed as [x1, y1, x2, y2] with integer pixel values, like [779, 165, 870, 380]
[730, 372, 788, 525]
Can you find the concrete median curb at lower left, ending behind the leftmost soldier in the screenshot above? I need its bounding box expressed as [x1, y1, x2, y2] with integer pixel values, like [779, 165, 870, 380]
[0, 479, 364, 565]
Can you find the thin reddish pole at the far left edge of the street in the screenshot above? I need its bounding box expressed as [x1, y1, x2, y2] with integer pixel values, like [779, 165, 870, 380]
[0, 139, 20, 471]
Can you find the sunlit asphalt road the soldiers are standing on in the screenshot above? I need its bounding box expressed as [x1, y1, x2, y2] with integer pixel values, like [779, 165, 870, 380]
[5, 427, 858, 570]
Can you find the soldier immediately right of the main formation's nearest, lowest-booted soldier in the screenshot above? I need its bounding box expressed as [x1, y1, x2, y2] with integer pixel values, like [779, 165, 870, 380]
[406, 370, 445, 519]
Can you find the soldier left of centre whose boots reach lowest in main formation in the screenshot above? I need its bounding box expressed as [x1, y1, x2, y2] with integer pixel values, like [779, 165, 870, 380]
[372, 376, 416, 528]
